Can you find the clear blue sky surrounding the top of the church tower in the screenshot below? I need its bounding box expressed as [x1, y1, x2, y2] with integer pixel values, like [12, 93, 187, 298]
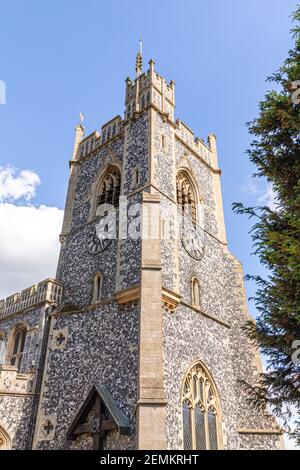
[0, 0, 298, 448]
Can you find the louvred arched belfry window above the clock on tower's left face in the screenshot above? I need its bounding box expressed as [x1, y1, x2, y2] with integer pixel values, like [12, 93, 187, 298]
[96, 166, 121, 216]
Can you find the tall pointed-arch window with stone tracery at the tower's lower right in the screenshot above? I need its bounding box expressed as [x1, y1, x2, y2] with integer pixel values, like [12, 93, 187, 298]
[182, 362, 221, 450]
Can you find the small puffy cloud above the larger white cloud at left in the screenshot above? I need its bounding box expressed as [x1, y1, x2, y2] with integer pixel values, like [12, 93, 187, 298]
[0, 165, 41, 202]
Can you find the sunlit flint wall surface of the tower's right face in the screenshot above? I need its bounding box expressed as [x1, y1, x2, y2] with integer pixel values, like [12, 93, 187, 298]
[154, 111, 280, 449]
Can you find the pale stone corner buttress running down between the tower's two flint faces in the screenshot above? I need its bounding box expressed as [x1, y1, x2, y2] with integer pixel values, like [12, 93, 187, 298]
[137, 189, 167, 450]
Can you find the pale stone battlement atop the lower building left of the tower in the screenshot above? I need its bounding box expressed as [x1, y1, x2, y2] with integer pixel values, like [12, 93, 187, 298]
[0, 279, 63, 319]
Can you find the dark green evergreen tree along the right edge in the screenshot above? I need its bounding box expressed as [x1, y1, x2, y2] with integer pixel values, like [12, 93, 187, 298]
[233, 6, 300, 443]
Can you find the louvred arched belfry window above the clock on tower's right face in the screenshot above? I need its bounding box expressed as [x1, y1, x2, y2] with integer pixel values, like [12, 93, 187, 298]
[176, 171, 197, 225]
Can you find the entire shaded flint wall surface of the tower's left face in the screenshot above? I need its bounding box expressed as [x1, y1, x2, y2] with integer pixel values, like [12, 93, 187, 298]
[37, 113, 149, 449]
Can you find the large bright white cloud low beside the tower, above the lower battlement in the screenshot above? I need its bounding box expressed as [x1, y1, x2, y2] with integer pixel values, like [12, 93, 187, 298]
[0, 203, 63, 298]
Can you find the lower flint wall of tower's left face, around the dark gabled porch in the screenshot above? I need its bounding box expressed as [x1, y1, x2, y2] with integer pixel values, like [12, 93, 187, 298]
[37, 304, 138, 449]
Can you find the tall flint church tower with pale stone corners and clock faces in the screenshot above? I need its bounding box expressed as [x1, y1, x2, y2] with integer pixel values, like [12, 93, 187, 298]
[29, 51, 281, 449]
